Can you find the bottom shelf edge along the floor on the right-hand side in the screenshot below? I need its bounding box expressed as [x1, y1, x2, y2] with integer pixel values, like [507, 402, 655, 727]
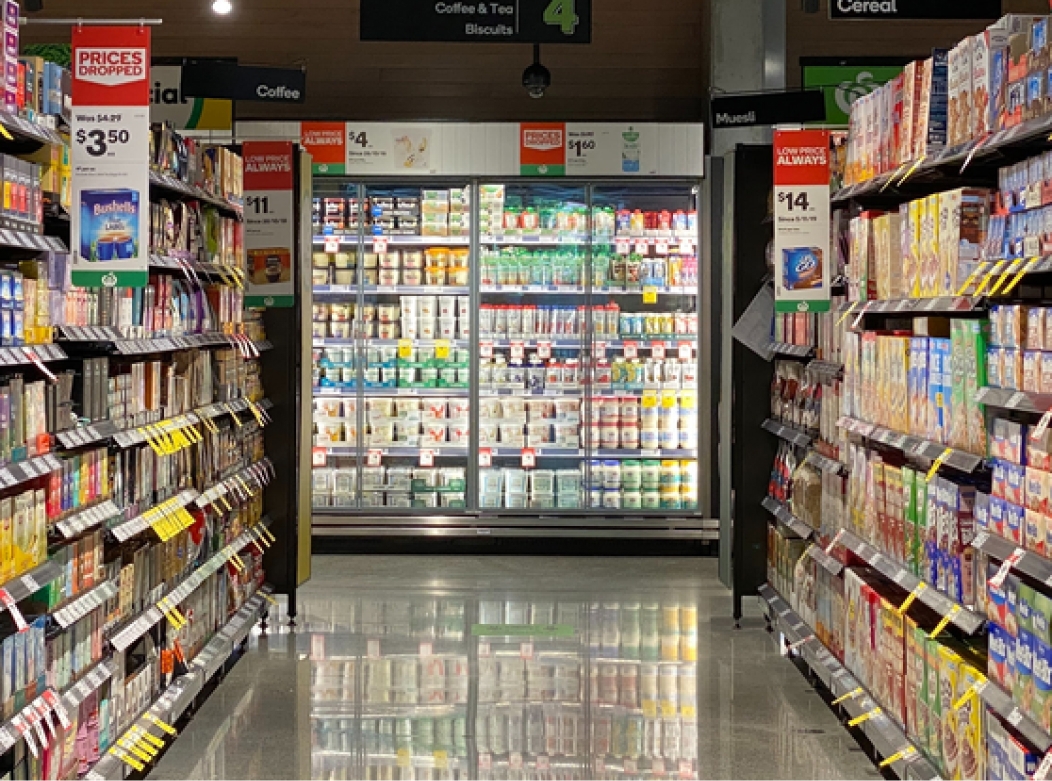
[760, 584, 938, 779]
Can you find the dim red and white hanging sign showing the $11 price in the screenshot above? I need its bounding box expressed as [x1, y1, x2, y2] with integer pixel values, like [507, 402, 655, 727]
[242, 141, 296, 307]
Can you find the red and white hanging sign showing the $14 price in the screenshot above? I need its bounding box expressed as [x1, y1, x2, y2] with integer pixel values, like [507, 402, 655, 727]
[774, 131, 830, 312]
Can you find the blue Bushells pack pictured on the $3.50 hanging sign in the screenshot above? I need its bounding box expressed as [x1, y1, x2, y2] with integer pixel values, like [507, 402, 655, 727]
[80, 189, 142, 262]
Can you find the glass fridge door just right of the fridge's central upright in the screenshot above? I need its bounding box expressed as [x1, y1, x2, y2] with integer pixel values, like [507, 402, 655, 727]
[479, 182, 589, 515]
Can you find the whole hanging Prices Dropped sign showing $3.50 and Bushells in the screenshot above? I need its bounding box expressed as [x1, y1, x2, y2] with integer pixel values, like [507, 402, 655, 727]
[69, 26, 149, 287]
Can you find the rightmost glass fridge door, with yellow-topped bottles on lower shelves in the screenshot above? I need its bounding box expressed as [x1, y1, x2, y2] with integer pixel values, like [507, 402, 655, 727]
[583, 188, 700, 517]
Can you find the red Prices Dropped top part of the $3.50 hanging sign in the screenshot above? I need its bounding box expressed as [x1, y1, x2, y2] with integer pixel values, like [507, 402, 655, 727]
[72, 25, 149, 106]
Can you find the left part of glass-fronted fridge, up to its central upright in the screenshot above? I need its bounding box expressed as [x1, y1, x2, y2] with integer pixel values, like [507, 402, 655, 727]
[315, 182, 472, 518]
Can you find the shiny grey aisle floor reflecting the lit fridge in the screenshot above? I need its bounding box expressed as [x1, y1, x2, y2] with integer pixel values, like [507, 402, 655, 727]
[150, 556, 878, 779]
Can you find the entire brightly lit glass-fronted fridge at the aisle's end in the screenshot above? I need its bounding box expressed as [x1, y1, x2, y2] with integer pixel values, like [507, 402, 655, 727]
[311, 177, 705, 528]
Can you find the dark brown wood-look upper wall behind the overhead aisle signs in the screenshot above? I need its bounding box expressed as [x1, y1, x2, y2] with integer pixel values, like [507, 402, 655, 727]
[24, 0, 709, 121]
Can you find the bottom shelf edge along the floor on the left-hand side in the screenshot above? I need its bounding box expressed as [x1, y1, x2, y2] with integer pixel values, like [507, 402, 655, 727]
[85, 586, 269, 781]
